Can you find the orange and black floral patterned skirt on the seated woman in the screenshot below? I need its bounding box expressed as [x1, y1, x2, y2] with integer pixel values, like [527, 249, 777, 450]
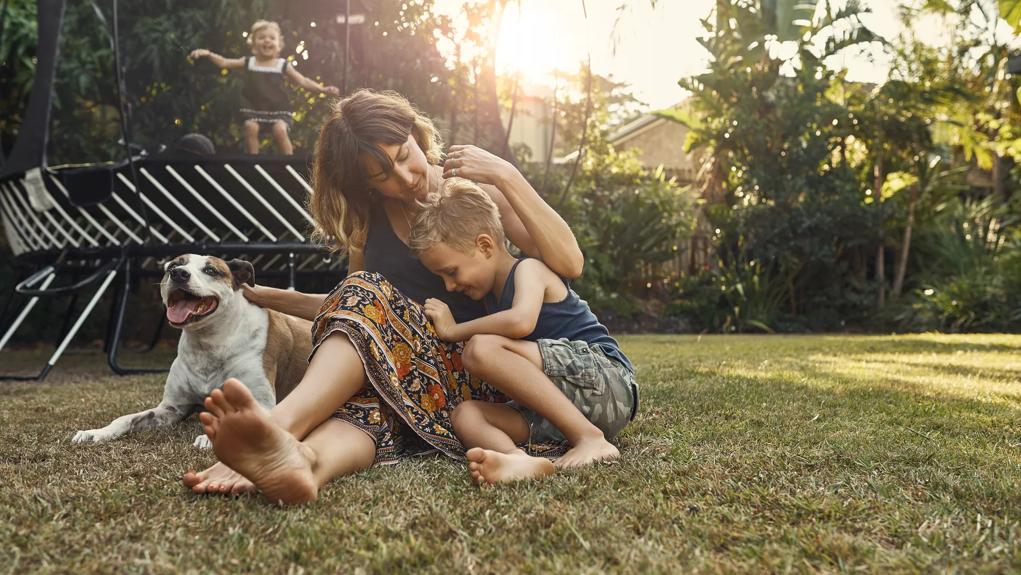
[312, 272, 506, 465]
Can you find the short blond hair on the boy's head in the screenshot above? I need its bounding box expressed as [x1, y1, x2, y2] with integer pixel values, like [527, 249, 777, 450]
[408, 178, 503, 255]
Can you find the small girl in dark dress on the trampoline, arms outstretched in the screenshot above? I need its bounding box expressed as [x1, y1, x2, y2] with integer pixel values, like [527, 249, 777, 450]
[189, 20, 340, 155]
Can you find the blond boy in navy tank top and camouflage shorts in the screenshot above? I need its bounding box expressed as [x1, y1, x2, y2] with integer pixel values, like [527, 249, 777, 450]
[409, 178, 638, 484]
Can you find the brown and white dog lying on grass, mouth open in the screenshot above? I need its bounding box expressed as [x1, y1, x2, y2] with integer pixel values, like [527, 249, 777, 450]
[71, 254, 311, 448]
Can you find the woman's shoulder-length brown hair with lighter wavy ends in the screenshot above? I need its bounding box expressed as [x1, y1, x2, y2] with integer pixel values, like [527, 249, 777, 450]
[308, 90, 441, 251]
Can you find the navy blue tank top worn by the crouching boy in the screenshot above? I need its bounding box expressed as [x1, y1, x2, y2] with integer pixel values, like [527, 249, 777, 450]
[486, 257, 635, 373]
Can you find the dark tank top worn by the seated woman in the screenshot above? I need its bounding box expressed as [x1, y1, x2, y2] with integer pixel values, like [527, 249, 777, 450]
[364, 202, 486, 323]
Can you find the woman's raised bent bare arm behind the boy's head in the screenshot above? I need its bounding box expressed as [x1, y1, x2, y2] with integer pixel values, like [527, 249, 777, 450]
[443, 146, 585, 280]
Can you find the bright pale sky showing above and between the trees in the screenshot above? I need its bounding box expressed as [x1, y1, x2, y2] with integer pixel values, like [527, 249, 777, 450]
[436, 0, 1012, 109]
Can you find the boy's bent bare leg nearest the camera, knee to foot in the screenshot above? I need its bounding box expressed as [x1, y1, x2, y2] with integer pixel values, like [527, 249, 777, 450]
[461, 335, 620, 467]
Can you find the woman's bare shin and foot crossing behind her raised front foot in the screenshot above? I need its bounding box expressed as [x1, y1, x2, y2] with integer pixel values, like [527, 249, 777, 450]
[183, 332, 366, 493]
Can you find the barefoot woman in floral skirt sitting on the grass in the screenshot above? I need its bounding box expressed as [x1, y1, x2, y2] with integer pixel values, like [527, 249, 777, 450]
[184, 90, 584, 504]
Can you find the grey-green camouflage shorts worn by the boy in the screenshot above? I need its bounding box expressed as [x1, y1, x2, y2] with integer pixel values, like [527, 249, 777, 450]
[507, 339, 637, 443]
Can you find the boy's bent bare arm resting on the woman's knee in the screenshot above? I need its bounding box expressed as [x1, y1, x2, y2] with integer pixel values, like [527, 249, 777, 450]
[426, 260, 546, 341]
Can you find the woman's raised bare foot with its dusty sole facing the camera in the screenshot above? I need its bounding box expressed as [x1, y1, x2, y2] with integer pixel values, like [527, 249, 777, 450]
[199, 378, 319, 504]
